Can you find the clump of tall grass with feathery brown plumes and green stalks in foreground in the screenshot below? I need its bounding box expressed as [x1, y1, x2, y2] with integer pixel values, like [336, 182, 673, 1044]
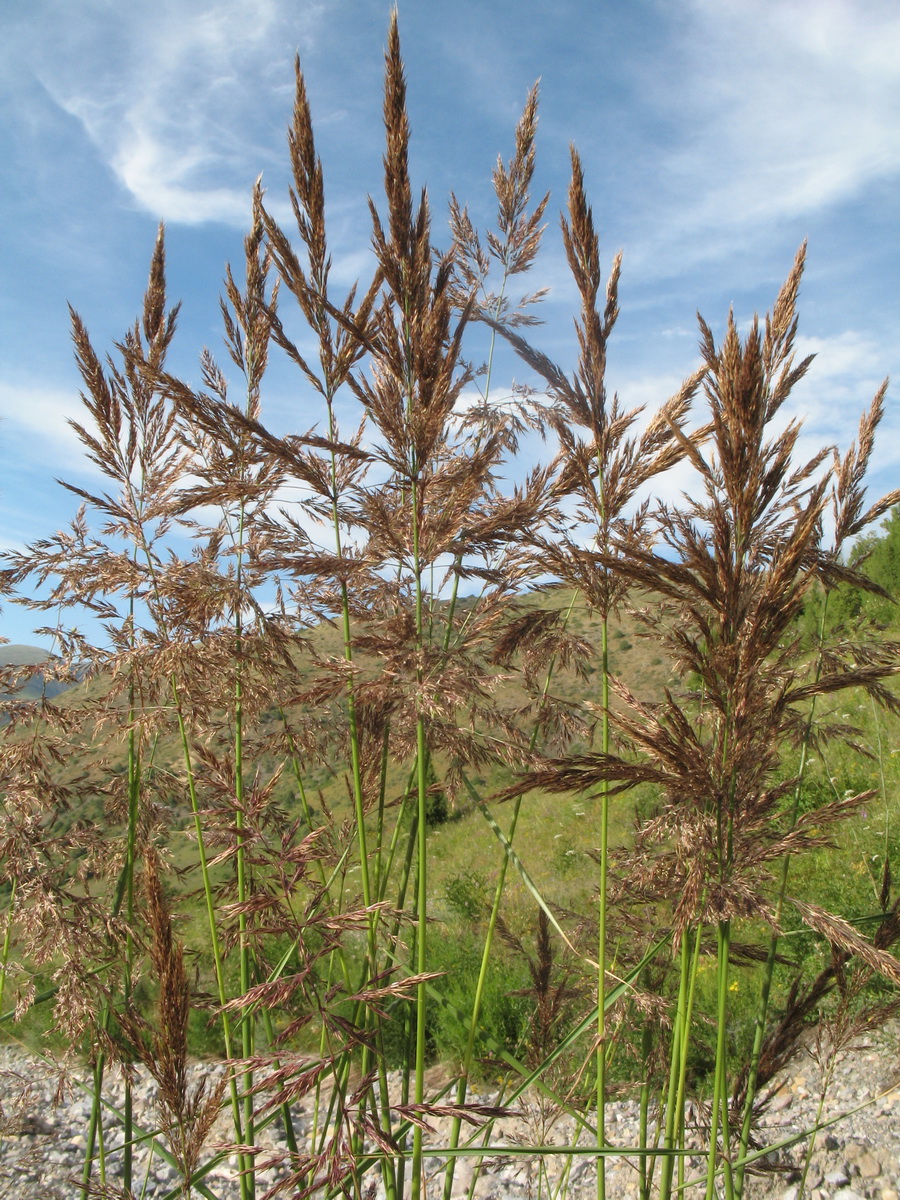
[0, 11, 900, 1200]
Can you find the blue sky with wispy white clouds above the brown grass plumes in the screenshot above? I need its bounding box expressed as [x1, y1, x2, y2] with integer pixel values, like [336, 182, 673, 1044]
[0, 0, 900, 641]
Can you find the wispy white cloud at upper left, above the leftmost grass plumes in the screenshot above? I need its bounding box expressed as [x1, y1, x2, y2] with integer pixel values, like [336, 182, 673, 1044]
[36, 0, 323, 227]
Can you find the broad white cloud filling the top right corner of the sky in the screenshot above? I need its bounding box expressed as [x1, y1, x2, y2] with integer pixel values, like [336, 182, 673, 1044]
[640, 0, 900, 265]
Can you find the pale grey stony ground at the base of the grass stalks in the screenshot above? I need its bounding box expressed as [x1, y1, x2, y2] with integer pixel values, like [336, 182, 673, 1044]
[0, 1030, 900, 1200]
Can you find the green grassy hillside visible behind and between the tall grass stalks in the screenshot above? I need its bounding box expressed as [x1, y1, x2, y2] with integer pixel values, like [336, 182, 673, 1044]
[5, 589, 900, 1058]
